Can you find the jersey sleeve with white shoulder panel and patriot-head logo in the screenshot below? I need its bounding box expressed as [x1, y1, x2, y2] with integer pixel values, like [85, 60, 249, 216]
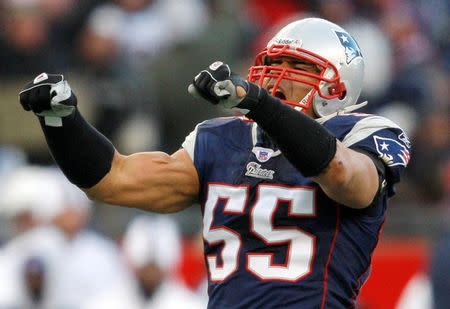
[342, 116, 411, 196]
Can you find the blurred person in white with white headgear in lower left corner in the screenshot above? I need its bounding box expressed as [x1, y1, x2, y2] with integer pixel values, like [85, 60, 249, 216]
[0, 167, 141, 308]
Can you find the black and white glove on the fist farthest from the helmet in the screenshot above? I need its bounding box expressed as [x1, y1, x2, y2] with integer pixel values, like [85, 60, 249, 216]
[19, 73, 77, 126]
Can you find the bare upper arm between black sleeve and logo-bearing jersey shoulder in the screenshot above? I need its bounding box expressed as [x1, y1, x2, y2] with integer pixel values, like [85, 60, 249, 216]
[313, 142, 379, 208]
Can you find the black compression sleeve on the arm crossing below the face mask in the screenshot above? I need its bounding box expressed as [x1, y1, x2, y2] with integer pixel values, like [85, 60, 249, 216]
[239, 84, 336, 177]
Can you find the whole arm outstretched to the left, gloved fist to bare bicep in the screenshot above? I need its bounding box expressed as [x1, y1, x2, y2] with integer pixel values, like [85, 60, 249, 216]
[20, 73, 199, 212]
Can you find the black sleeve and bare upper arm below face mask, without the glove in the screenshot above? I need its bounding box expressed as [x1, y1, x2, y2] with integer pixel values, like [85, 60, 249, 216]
[243, 89, 378, 208]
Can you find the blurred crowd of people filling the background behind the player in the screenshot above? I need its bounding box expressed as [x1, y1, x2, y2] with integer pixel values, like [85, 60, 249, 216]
[0, 0, 450, 308]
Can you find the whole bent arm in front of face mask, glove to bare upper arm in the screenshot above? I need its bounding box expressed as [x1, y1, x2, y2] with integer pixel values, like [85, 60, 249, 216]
[189, 62, 382, 208]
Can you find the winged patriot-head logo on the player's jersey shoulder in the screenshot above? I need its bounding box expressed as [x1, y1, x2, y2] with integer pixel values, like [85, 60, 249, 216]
[373, 135, 411, 166]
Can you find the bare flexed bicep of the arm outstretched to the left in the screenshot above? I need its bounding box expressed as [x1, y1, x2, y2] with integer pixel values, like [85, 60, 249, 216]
[86, 149, 199, 212]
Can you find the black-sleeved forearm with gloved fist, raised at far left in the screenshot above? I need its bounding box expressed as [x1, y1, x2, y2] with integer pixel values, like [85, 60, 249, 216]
[19, 73, 115, 189]
